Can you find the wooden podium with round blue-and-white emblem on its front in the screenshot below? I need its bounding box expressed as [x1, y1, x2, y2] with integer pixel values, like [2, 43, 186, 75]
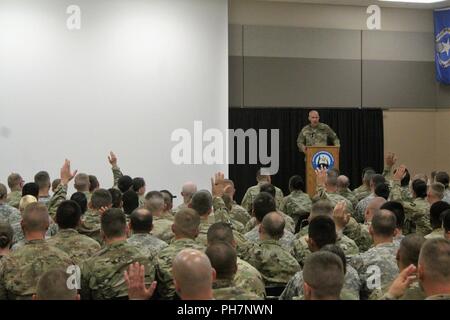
[306, 146, 340, 197]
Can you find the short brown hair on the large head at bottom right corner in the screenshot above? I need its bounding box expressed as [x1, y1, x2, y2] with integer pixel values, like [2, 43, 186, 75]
[419, 238, 450, 284]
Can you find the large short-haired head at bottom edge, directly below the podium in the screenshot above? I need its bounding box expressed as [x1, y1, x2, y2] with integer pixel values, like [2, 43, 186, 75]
[303, 251, 344, 300]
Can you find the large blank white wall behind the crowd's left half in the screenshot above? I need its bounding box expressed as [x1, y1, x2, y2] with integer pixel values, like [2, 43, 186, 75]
[0, 0, 228, 205]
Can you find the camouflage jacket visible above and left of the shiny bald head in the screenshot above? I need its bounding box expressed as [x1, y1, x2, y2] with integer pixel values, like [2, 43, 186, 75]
[156, 238, 205, 300]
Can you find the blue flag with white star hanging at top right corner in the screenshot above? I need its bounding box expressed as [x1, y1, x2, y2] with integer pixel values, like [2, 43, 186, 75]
[434, 8, 450, 84]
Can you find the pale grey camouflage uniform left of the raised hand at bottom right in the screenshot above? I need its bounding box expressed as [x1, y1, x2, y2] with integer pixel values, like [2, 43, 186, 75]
[350, 242, 399, 297]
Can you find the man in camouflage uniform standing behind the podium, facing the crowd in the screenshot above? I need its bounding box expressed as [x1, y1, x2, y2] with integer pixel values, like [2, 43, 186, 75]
[297, 110, 340, 153]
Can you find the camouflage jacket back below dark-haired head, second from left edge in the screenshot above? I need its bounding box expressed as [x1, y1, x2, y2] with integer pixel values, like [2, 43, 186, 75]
[47, 229, 100, 265]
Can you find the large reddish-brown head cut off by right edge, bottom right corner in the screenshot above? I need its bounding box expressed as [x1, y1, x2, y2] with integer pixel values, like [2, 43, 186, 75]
[418, 238, 450, 296]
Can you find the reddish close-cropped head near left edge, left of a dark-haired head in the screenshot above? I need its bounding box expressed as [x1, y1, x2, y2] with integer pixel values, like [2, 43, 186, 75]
[20, 202, 50, 239]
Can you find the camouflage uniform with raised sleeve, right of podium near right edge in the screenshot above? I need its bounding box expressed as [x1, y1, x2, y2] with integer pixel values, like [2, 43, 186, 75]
[391, 181, 432, 236]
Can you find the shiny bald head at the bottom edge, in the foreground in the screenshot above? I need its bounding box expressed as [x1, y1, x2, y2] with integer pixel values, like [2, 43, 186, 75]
[172, 248, 216, 300]
